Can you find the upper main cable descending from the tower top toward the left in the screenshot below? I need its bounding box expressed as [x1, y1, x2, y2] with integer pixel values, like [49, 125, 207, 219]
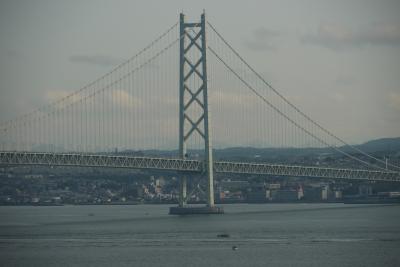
[0, 22, 178, 132]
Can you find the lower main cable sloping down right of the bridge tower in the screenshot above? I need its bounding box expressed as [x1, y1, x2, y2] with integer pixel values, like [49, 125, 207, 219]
[208, 46, 398, 175]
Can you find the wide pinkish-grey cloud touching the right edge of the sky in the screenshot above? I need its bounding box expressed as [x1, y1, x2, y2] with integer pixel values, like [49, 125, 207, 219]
[300, 23, 400, 50]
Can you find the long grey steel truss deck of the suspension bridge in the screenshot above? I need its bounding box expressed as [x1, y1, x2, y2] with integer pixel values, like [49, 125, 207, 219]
[0, 151, 400, 182]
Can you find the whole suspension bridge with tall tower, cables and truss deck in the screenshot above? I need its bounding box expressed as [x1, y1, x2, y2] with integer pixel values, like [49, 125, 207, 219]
[0, 13, 400, 212]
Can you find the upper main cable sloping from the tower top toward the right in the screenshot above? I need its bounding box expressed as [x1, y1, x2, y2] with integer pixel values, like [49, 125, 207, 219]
[207, 22, 400, 170]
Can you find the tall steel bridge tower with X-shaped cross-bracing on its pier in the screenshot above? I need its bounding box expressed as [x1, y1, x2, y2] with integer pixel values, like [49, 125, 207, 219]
[170, 12, 223, 214]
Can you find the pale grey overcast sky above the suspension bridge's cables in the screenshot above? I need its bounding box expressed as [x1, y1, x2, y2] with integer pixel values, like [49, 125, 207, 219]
[0, 0, 400, 147]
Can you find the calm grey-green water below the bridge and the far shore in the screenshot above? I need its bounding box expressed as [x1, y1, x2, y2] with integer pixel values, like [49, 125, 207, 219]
[0, 204, 400, 267]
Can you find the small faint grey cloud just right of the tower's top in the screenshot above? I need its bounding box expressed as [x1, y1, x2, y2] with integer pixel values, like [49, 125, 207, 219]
[244, 27, 279, 51]
